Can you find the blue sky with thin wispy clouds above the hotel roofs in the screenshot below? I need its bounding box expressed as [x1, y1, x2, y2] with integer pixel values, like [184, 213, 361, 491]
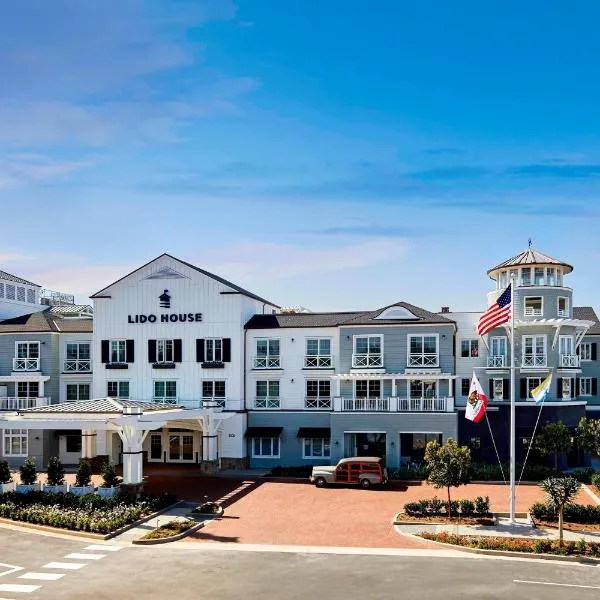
[0, 0, 600, 310]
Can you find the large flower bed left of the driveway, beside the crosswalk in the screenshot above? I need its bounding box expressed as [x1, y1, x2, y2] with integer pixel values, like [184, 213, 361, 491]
[0, 492, 175, 534]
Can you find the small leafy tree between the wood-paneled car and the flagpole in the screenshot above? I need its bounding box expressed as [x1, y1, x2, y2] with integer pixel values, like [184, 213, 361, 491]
[425, 438, 471, 518]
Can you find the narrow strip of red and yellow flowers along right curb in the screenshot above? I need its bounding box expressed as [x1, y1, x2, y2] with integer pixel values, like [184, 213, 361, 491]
[419, 532, 600, 558]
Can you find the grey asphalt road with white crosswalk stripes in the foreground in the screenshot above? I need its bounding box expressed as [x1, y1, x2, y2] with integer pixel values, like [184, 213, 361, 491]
[0, 528, 600, 600]
